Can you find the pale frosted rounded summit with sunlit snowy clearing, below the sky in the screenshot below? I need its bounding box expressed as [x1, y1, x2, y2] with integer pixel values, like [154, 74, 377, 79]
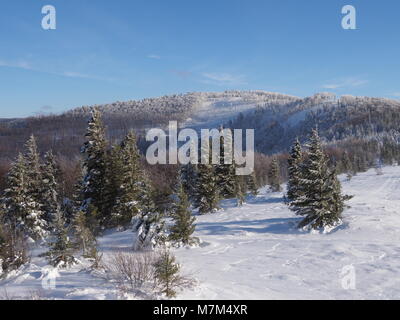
[66, 91, 298, 126]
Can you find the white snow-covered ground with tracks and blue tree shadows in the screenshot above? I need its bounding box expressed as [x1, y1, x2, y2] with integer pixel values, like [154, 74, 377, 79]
[0, 167, 400, 299]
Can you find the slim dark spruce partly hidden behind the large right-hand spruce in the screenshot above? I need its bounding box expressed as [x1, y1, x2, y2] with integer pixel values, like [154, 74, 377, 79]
[286, 139, 303, 203]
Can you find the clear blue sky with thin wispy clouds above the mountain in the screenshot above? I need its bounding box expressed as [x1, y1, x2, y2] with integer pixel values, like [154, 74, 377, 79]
[0, 0, 400, 118]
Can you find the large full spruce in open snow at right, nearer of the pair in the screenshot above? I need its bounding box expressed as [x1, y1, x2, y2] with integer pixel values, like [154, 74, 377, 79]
[290, 130, 344, 229]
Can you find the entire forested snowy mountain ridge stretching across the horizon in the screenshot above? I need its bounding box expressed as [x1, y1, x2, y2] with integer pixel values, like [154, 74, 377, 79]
[0, 91, 400, 158]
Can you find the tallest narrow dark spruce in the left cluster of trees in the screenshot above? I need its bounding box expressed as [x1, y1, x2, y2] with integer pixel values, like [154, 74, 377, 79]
[82, 109, 109, 226]
